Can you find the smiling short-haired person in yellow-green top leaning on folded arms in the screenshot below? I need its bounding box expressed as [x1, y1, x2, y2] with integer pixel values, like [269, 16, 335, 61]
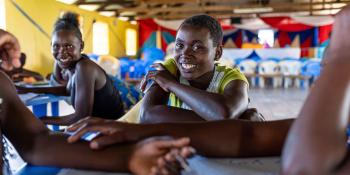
[141, 15, 248, 123]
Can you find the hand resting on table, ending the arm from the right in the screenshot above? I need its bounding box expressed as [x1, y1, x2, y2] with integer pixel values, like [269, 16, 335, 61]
[67, 117, 148, 149]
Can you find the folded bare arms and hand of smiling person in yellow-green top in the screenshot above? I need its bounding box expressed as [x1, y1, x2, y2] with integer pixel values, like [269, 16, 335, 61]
[141, 64, 248, 121]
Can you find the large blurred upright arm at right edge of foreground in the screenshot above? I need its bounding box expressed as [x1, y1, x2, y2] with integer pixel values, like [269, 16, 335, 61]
[282, 7, 350, 174]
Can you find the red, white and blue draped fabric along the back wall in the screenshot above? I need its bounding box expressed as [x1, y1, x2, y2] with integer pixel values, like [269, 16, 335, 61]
[138, 16, 334, 51]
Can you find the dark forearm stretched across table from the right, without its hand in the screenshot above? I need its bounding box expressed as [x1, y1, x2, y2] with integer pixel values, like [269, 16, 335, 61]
[142, 119, 293, 157]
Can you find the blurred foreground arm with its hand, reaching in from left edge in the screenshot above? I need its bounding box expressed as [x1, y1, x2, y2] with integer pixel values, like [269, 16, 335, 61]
[0, 71, 189, 174]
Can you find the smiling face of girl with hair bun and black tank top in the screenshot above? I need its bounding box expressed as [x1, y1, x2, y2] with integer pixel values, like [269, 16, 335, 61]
[51, 30, 83, 69]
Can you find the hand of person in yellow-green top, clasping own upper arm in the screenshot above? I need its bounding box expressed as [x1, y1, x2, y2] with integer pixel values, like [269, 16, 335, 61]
[140, 63, 177, 92]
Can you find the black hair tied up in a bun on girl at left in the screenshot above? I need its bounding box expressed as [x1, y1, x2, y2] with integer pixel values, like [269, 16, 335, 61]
[53, 12, 83, 42]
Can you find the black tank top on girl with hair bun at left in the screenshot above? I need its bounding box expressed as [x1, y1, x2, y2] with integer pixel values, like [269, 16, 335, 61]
[71, 66, 125, 119]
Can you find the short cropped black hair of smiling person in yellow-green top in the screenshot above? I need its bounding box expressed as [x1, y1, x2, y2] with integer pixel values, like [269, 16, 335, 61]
[179, 14, 223, 46]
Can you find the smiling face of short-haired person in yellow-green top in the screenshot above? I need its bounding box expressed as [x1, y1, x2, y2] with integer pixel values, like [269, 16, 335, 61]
[175, 25, 221, 80]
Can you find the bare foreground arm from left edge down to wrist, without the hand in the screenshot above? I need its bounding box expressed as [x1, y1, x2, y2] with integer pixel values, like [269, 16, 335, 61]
[0, 71, 131, 171]
